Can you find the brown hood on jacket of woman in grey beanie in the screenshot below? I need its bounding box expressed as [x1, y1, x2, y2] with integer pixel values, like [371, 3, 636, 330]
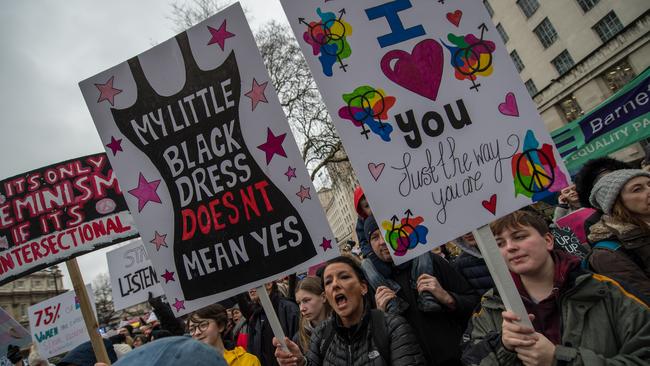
[589, 215, 650, 249]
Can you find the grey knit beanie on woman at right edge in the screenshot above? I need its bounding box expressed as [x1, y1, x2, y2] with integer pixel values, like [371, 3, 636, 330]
[589, 169, 650, 215]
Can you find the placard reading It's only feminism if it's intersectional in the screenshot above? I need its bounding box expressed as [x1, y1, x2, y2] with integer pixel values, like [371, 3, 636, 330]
[0, 153, 138, 285]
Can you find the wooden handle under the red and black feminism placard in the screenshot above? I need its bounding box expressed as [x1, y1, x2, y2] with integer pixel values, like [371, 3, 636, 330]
[65, 258, 111, 365]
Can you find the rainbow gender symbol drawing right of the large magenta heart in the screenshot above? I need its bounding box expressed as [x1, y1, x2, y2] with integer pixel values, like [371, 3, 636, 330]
[443, 26, 495, 91]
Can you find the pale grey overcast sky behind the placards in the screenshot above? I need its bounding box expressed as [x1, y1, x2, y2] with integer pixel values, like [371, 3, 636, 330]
[0, 0, 287, 288]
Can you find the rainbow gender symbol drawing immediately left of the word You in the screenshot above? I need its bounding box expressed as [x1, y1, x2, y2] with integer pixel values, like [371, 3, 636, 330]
[339, 85, 396, 142]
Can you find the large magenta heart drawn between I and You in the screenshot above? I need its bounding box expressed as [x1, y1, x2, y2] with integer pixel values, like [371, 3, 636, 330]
[380, 39, 445, 101]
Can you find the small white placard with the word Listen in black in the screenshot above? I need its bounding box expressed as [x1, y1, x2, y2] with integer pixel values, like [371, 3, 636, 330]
[106, 239, 163, 310]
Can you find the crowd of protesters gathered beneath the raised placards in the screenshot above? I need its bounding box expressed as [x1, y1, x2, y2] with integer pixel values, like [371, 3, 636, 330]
[9, 153, 650, 366]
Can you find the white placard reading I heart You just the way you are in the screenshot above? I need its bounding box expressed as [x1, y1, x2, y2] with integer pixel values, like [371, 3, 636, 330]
[281, 0, 567, 264]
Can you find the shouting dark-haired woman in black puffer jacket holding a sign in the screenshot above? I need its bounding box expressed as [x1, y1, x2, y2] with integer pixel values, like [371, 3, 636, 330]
[273, 256, 425, 366]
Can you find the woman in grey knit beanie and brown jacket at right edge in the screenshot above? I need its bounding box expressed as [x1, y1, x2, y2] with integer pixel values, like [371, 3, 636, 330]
[589, 169, 650, 298]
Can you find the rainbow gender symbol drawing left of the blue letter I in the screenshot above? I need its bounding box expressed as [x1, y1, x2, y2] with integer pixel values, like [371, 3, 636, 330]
[298, 8, 352, 76]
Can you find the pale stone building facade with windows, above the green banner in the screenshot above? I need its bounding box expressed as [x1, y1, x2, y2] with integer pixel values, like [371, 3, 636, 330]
[483, 0, 650, 160]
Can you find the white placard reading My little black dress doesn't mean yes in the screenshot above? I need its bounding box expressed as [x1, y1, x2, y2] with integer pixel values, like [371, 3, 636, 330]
[80, 4, 338, 315]
